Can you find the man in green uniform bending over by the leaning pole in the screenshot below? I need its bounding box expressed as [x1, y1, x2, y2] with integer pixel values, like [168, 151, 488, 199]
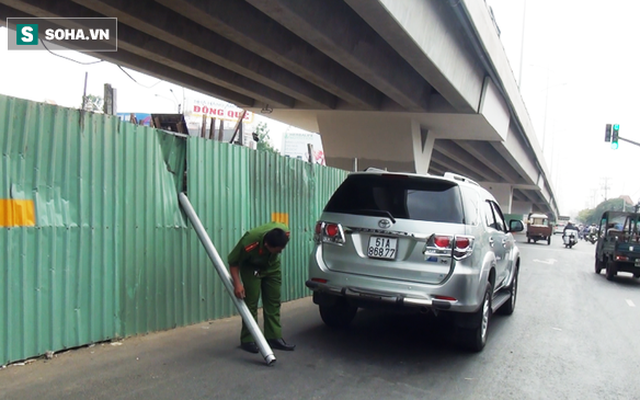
[227, 222, 296, 353]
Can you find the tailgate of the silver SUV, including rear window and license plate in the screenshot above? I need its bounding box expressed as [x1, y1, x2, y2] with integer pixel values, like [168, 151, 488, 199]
[321, 173, 464, 284]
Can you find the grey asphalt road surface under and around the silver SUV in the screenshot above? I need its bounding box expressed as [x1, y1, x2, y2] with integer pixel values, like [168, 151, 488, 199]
[0, 235, 640, 400]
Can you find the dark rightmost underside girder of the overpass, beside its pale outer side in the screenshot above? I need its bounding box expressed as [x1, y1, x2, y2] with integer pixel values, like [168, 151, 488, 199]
[247, 0, 432, 111]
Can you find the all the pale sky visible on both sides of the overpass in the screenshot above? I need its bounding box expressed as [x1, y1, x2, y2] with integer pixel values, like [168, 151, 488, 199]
[0, 0, 640, 216]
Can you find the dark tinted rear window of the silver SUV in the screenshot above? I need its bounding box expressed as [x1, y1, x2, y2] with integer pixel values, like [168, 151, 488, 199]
[324, 174, 463, 223]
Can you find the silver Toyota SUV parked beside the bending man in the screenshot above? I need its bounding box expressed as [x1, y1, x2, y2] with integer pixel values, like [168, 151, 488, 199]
[306, 170, 524, 351]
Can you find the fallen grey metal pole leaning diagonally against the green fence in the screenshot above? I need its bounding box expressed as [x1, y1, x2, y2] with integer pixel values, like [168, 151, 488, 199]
[179, 193, 276, 365]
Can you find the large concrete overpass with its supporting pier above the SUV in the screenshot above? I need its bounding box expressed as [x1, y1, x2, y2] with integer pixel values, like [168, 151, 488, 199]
[0, 0, 559, 219]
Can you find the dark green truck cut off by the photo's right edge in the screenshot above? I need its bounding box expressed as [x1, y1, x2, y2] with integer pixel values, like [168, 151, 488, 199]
[595, 211, 640, 280]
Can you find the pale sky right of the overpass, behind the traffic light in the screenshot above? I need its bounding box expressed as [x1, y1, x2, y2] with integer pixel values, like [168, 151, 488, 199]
[487, 0, 640, 216]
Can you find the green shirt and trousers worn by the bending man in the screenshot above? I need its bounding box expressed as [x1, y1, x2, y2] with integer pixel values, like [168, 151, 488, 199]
[227, 222, 289, 343]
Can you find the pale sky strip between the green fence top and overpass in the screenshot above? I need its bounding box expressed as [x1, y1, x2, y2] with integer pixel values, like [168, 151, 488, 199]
[0, 27, 296, 150]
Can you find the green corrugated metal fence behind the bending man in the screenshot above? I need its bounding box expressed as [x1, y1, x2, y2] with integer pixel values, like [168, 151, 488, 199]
[0, 96, 346, 365]
